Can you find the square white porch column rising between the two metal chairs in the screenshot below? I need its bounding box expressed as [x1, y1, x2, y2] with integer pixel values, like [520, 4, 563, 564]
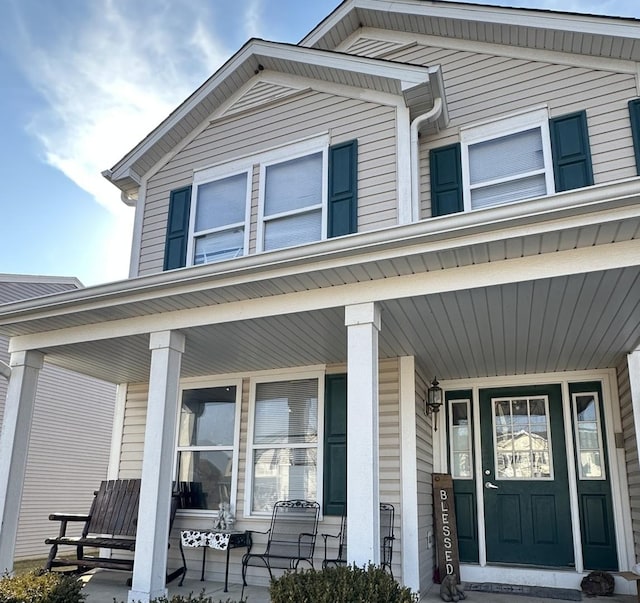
[345, 303, 380, 565]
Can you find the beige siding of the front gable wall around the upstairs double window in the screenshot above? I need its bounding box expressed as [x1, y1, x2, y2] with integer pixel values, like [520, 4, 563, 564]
[139, 91, 397, 275]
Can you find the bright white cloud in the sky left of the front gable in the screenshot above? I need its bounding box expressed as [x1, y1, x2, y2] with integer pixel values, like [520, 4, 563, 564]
[14, 0, 228, 215]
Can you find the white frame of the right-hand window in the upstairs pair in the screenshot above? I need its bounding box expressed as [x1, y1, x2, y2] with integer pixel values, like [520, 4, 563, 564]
[256, 137, 329, 253]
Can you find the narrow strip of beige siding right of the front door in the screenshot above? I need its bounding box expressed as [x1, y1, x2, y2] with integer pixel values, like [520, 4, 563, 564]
[616, 355, 640, 559]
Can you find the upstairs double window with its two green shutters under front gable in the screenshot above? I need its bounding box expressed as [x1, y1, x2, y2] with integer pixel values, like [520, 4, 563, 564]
[164, 135, 358, 270]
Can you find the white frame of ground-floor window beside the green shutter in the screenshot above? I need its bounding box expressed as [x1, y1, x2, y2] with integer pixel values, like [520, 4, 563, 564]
[244, 370, 325, 517]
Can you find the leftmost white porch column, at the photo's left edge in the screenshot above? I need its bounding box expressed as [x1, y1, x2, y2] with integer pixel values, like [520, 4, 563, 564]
[0, 351, 44, 575]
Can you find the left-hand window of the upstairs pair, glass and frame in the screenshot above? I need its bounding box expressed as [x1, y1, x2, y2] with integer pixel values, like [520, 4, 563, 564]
[190, 171, 251, 264]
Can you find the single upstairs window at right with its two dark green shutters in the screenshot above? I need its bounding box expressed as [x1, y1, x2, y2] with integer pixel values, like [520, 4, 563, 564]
[429, 108, 594, 216]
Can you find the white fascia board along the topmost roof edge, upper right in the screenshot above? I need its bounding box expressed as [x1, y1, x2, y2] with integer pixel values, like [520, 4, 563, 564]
[300, 0, 640, 46]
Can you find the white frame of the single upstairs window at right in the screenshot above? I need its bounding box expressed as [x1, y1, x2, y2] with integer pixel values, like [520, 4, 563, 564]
[460, 107, 555, 212]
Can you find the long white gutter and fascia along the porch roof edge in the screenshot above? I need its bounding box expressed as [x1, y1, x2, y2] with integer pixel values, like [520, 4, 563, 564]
[0, 177, 640, 325]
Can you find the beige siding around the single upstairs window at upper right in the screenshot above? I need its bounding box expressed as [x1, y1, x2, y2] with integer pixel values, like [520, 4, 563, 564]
[376, 45, 637, 218]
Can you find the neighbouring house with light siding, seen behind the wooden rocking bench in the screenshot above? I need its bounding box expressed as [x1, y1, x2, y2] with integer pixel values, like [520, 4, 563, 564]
[0, 274, 116, 559]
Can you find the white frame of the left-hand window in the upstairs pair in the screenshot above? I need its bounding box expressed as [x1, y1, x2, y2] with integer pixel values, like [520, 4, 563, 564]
[187, 166, 253, 266]
